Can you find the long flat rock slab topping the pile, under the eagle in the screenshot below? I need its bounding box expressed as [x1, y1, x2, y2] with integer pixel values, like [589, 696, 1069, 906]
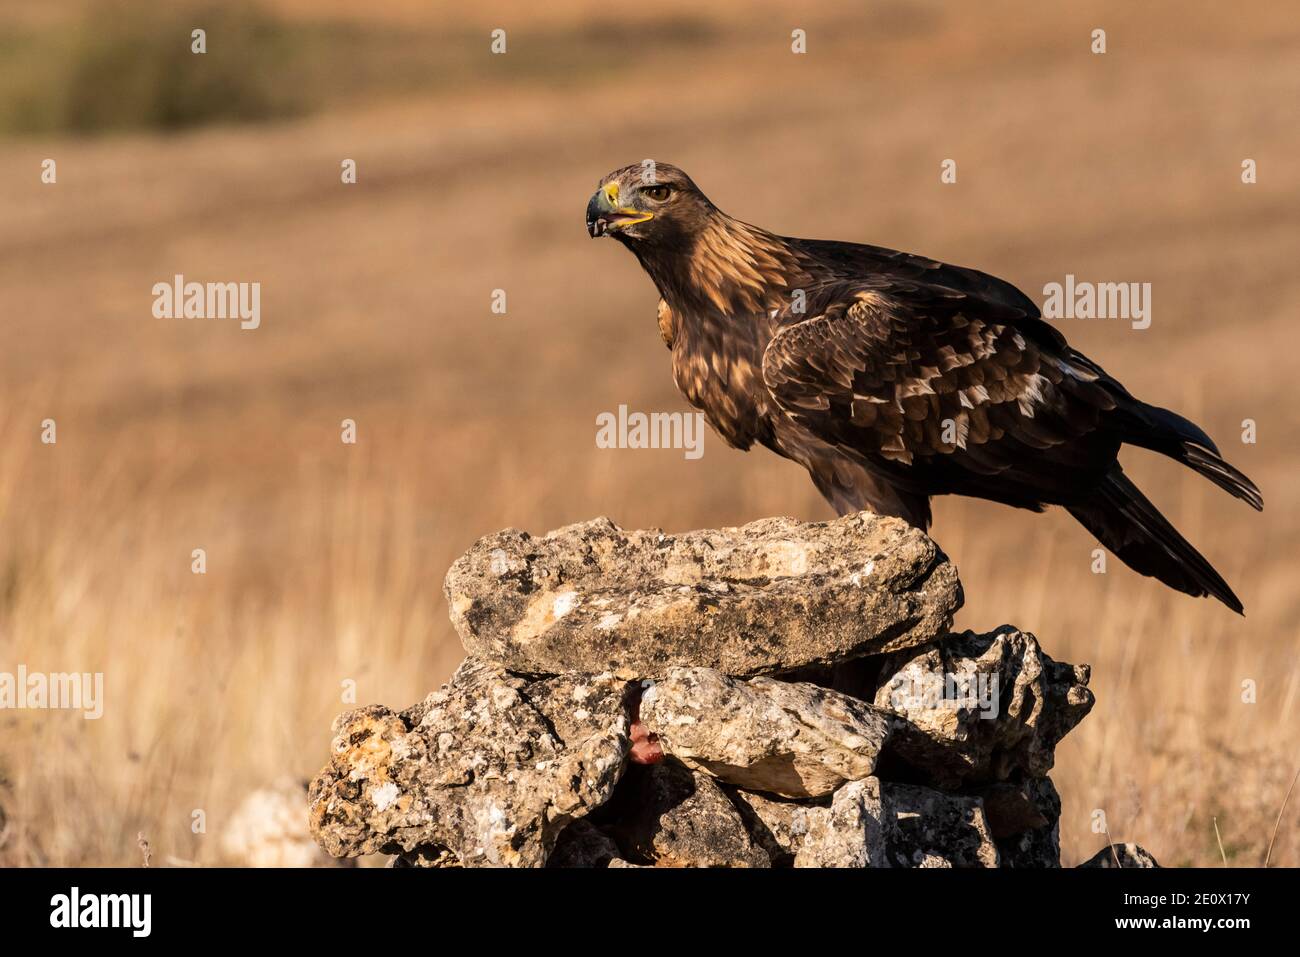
[445, 512, 962, 677]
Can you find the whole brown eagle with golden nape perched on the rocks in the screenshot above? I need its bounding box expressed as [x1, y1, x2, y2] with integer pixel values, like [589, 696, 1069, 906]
[588, 164, 1262, 612]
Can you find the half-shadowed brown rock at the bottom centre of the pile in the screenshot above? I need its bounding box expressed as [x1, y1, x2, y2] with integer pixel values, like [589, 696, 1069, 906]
[615, 758, 771, 867]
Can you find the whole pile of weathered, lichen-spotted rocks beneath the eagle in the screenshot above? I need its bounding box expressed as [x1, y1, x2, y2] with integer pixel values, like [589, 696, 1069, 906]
[309, 514, 1154, 867]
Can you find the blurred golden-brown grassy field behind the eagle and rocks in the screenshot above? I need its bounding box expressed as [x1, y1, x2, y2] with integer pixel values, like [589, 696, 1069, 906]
[0, 0, 1300, 866]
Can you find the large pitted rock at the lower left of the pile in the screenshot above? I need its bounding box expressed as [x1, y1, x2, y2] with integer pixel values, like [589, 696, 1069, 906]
[309, 659, 629, 867]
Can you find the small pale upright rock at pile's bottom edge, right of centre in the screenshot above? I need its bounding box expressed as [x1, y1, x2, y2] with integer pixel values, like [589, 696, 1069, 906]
[794, 778, 891, 867]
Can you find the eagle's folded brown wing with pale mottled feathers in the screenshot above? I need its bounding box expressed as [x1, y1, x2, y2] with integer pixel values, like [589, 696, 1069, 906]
[763, 280, 1122, 508]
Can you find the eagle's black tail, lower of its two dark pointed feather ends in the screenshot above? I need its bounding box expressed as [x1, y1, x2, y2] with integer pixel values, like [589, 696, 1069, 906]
[1070, 463, 1258, 615]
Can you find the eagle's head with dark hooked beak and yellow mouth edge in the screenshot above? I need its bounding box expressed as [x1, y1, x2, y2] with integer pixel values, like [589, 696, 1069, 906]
[586, 160, 718, 250]
